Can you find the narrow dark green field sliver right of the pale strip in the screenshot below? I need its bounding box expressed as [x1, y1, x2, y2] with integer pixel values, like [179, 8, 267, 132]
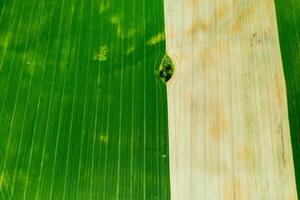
[275, 0, 300, 199]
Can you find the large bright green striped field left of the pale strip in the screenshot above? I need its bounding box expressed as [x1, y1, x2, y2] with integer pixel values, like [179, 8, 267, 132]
[0, 0, 170, 200]
